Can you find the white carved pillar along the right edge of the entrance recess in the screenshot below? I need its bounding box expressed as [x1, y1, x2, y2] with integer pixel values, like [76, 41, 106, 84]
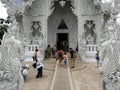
[71, 0, 85, 59]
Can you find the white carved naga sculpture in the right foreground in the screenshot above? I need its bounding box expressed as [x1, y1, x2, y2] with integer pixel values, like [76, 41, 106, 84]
[101, 17, 120, 90]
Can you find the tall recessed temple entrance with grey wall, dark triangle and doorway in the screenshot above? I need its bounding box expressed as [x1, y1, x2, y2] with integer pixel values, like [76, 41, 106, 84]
[47, 1, 78, 51]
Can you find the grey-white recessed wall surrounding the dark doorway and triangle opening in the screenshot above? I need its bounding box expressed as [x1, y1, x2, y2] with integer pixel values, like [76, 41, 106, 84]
[48, 1, 78, 49]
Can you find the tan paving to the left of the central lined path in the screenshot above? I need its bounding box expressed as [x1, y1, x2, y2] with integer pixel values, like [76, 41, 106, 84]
[24, 59, 56, 90]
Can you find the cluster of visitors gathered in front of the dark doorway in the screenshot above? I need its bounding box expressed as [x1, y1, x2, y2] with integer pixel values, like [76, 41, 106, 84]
[45, 45, 77, 68]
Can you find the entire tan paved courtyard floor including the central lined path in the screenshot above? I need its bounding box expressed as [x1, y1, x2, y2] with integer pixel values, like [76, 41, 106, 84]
[24, 58, 101, 90]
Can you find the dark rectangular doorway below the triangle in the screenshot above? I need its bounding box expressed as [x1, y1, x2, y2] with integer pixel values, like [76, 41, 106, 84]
[57, 33, 69, 52]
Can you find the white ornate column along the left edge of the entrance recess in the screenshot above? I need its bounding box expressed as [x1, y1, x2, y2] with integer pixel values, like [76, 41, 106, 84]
[39, 0, 54, 61]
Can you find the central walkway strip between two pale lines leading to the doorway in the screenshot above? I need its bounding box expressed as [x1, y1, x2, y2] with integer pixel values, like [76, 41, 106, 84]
[51, 62, 72, 90]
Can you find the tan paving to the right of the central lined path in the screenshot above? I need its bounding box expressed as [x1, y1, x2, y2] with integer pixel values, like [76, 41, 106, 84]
[71, 62, 101, 90]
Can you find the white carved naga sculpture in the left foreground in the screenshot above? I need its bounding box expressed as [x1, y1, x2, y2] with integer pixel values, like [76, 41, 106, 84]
[0, 22, 24, 90]
